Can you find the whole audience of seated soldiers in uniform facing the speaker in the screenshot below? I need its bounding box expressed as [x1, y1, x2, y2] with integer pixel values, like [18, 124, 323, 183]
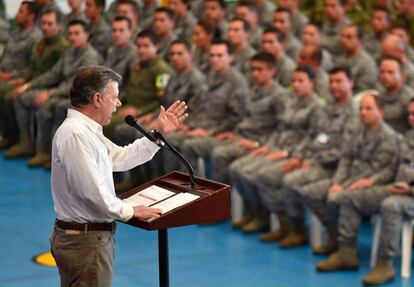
[0, 0, 414, 284]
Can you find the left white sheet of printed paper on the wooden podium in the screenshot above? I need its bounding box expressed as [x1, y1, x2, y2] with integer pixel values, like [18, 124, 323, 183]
[122, 185, 175, 206]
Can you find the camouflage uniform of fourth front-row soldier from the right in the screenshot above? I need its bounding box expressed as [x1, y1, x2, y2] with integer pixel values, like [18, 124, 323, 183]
[229, 94, 321, 217]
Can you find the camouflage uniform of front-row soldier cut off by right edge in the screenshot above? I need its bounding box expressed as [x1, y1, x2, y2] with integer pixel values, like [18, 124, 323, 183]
[339, 130, 414, 252]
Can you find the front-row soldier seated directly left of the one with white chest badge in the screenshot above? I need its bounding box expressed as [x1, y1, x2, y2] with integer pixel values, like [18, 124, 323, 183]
[229, 67, 322, 236]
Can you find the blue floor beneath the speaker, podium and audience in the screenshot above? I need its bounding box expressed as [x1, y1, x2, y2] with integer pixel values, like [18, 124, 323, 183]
[0, 157, 414, 287]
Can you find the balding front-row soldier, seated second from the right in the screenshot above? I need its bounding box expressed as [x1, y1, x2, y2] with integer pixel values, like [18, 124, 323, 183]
[312, 91, 399, 271]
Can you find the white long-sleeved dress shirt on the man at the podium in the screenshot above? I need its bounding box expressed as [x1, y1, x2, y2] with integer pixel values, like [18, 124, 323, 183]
[51, 109, 159, 223]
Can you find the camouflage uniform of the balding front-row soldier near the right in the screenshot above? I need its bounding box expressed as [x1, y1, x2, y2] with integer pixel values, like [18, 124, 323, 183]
[299, 122, 398, 232]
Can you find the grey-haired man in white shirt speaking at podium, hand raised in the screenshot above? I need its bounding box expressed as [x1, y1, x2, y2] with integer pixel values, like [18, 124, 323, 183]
[51, 66, 187, 287]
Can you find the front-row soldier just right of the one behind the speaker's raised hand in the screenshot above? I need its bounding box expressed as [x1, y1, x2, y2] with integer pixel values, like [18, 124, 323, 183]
[182, 40, 248, 176]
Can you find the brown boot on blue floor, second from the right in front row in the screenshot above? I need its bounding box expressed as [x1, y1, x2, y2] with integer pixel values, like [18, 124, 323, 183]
[316, 247, 359, 272]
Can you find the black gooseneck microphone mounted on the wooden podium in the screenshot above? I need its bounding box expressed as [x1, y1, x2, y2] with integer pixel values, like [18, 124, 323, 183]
[124, 115, 197, 189]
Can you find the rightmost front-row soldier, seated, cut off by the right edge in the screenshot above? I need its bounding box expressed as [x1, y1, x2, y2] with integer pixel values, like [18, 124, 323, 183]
[318, 99, 414, 285]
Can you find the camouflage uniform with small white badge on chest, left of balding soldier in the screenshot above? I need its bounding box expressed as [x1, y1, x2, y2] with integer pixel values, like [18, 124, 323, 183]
[283, 99, 358, 226]
